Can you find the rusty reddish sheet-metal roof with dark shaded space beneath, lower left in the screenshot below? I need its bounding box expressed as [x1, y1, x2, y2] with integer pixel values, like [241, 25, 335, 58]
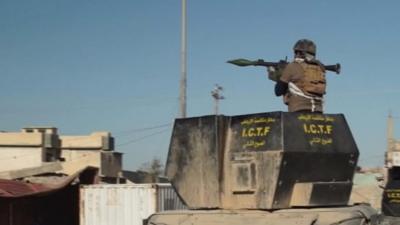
[0, 168, 97, 225]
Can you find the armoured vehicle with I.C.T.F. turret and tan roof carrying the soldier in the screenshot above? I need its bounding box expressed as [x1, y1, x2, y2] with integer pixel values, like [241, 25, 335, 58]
[148, 112, 379, 225]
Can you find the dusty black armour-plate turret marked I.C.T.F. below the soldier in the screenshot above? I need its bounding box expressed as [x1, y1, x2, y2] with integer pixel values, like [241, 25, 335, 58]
[166, 112, 359, 209]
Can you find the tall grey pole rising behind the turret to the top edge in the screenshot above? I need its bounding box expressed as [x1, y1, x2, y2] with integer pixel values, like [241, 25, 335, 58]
[179, 0, 187, 118]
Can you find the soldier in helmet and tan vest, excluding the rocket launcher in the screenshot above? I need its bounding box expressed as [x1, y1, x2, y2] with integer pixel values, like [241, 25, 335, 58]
[268, 39, 326, 113]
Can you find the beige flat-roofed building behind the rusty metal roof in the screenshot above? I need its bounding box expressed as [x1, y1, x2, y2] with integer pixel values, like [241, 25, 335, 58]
[0, 127, 122, 183]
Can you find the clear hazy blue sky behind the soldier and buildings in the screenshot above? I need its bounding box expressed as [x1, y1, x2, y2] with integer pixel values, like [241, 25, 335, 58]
[0, 0, 400, 169]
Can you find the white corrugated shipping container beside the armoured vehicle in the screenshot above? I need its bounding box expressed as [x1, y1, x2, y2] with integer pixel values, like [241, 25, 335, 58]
[80, 184, 187, 225]
